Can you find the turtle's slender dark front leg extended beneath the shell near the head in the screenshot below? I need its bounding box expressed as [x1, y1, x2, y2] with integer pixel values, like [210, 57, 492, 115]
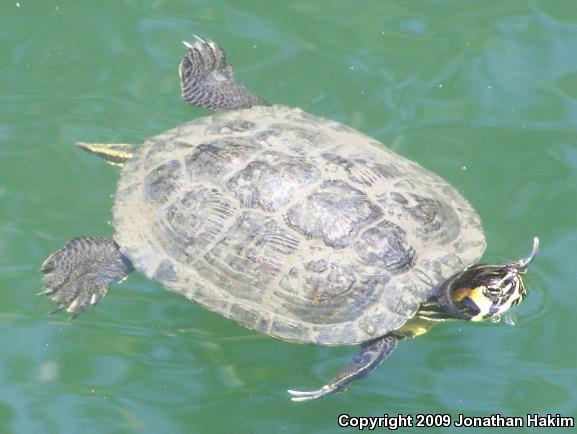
[288, 335, 399, 401]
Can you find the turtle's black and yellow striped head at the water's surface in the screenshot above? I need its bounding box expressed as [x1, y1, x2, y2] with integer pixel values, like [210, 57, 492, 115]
[420, 237, 539, 321]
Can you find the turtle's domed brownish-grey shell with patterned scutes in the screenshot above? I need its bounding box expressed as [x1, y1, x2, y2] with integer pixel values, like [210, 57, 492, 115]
[113, 106, 485, 345]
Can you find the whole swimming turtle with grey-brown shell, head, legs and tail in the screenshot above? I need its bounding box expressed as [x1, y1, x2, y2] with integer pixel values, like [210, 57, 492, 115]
[41, 36, 538, 401]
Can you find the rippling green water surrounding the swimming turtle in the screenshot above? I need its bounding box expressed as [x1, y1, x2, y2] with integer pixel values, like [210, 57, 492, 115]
[0, 0, 577, 433]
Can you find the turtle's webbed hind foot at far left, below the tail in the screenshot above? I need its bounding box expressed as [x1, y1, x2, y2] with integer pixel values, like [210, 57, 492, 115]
[39, 237, 133, 318]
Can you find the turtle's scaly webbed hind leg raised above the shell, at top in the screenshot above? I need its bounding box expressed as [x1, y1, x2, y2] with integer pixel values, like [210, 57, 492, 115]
[179, 36, 269, 111]
